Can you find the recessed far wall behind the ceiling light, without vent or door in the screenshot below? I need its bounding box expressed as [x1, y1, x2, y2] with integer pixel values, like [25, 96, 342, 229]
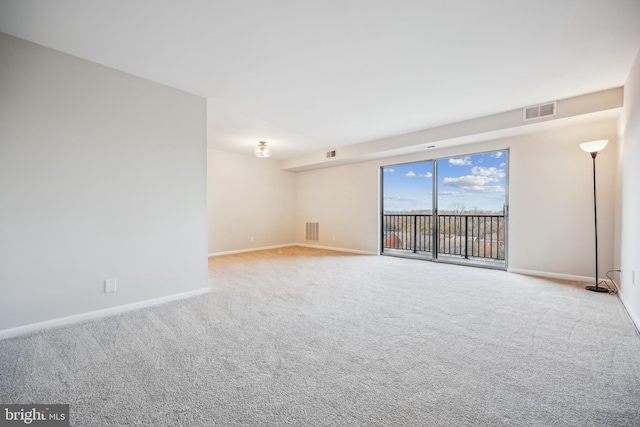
[207, 149, 295, 254]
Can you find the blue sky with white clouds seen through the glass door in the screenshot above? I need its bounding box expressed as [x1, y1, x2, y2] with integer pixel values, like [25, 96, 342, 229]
[383, 150, 507, 212]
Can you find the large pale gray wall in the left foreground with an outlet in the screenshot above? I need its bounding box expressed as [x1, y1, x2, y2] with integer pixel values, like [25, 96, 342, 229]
[0, 34, 207, 330]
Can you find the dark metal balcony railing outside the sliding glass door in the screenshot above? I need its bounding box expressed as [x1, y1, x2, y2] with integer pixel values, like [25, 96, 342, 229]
[382, 214, 505, 261]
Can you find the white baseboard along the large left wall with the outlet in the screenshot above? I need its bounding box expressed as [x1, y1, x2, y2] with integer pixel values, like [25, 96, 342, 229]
[0, 287, 210, 340]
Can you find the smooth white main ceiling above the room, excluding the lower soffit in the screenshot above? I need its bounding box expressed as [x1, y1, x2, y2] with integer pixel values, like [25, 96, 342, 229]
[0, 0, 640, 158]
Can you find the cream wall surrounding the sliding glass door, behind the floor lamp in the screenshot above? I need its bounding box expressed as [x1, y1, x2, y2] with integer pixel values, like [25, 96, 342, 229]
[296, 117, 616, 278]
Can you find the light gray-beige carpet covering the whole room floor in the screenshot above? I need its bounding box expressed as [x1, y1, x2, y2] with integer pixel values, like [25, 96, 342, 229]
[0, 248, 640, 426]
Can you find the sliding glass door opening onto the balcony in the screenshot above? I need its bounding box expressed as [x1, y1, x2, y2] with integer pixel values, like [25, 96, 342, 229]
[381, 150, 508, 268]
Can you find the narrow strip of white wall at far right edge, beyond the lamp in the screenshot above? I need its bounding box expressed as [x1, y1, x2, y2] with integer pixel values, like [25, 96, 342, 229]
[620, 48, 640, 328]
